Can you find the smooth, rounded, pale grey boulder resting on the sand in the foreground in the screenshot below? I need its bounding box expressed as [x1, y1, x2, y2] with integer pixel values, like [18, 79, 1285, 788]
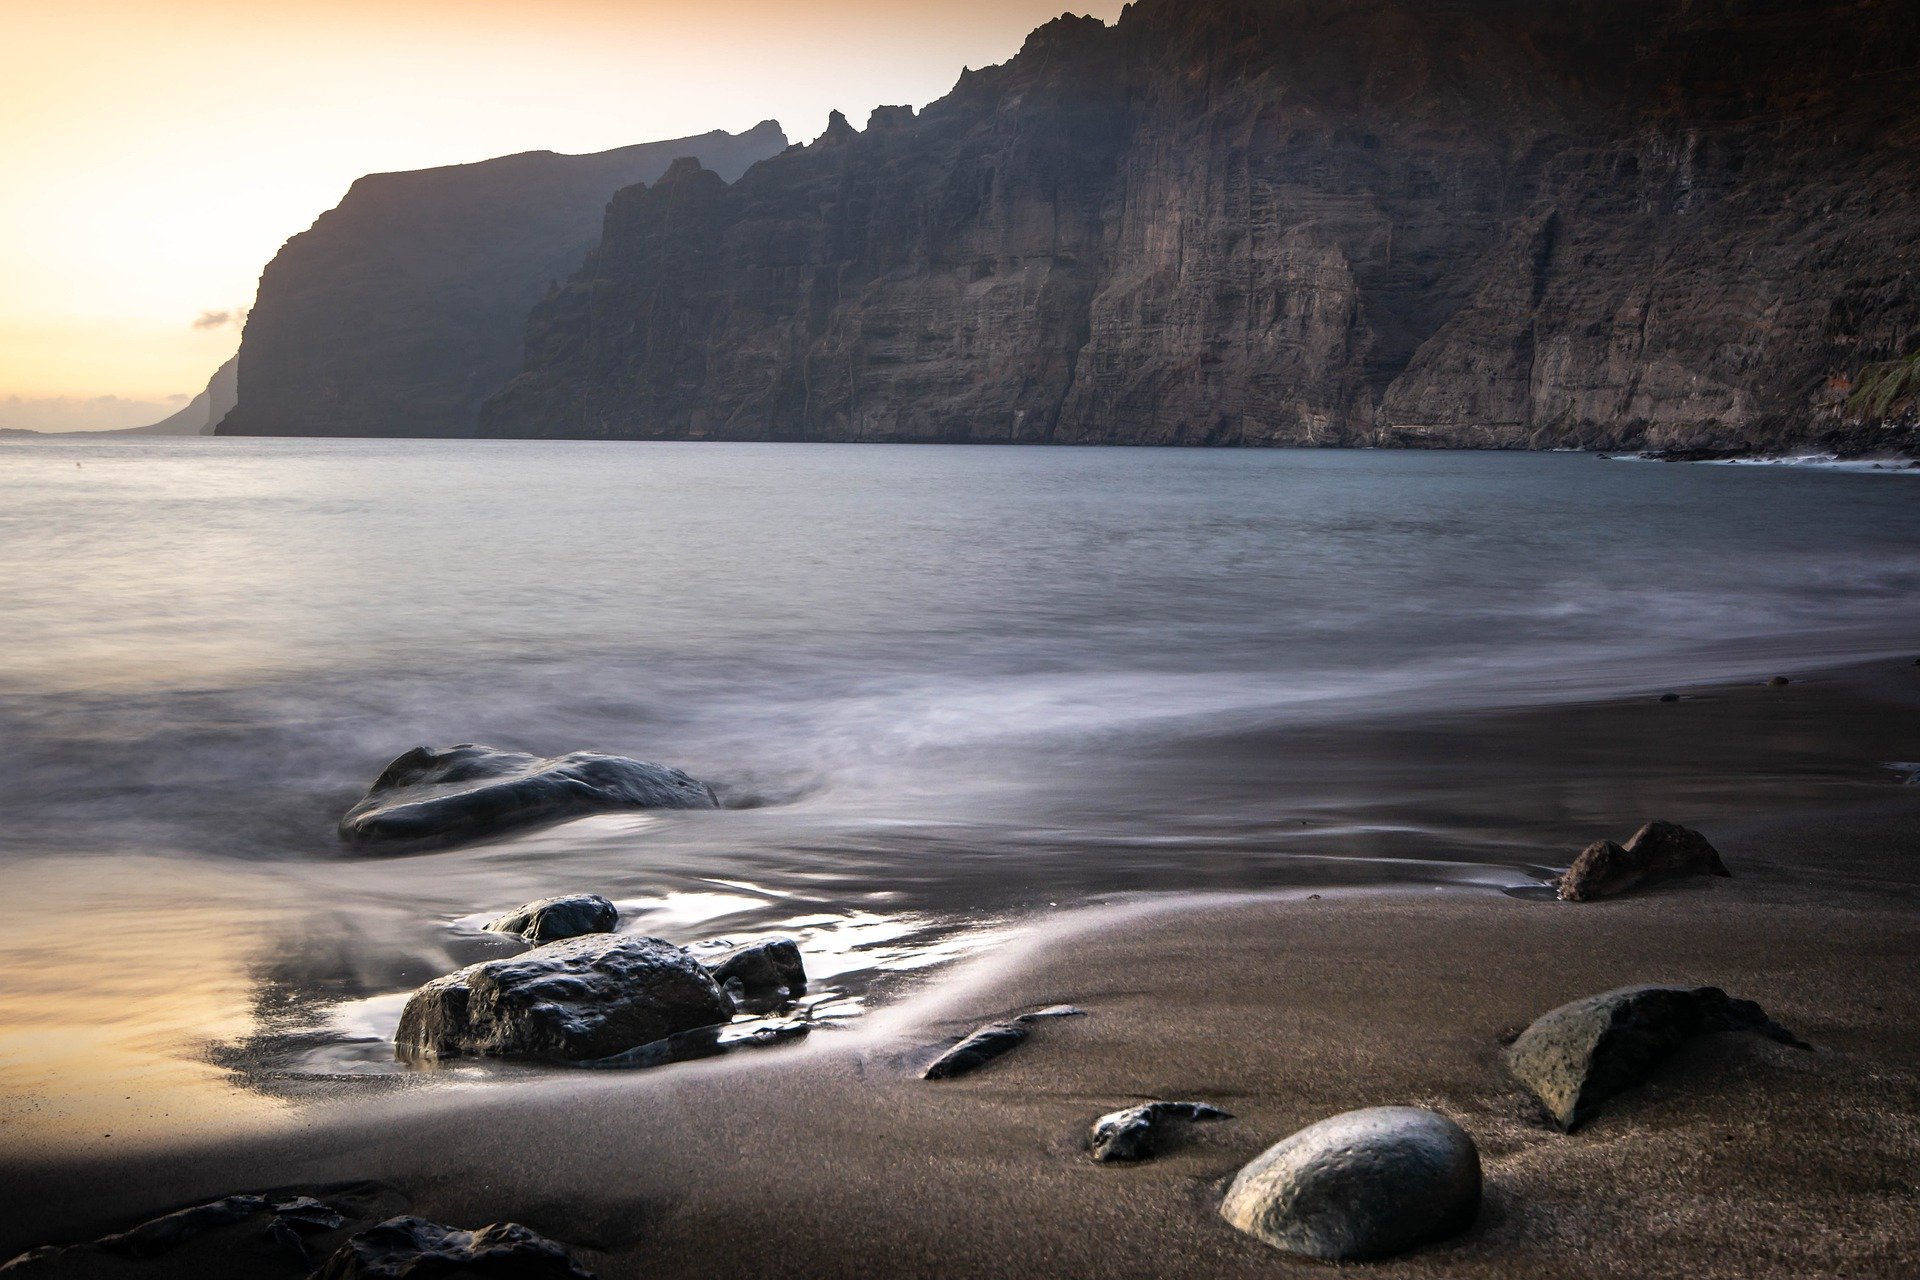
[1219, 1107, 1480, 1261]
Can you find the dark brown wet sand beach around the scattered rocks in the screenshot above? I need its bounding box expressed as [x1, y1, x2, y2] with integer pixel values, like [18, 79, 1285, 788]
[0, 664, 1920, 1278]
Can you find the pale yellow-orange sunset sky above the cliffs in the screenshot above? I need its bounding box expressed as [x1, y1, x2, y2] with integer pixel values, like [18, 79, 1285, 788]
[0, 0, 1119, 430]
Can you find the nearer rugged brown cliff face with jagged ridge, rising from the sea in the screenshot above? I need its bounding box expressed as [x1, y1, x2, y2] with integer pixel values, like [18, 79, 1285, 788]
[482, 0, 1920, 447]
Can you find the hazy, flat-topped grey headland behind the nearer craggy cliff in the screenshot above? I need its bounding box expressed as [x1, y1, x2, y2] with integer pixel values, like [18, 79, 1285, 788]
[219, 121, 787, 436]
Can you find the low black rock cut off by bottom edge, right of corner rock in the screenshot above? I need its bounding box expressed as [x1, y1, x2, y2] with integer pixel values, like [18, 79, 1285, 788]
[313, 1217, 593, 1280]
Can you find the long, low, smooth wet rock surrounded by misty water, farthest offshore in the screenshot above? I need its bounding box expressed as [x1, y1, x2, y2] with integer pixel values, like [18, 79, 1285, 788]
[340, 743, 720, 844]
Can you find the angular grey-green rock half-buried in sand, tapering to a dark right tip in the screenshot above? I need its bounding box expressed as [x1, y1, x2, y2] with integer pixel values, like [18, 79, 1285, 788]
[1507, 986, 1805, 1130]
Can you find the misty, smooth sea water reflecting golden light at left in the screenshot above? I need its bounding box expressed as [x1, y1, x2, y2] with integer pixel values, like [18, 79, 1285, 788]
[0, 439, 1920, 1142]
